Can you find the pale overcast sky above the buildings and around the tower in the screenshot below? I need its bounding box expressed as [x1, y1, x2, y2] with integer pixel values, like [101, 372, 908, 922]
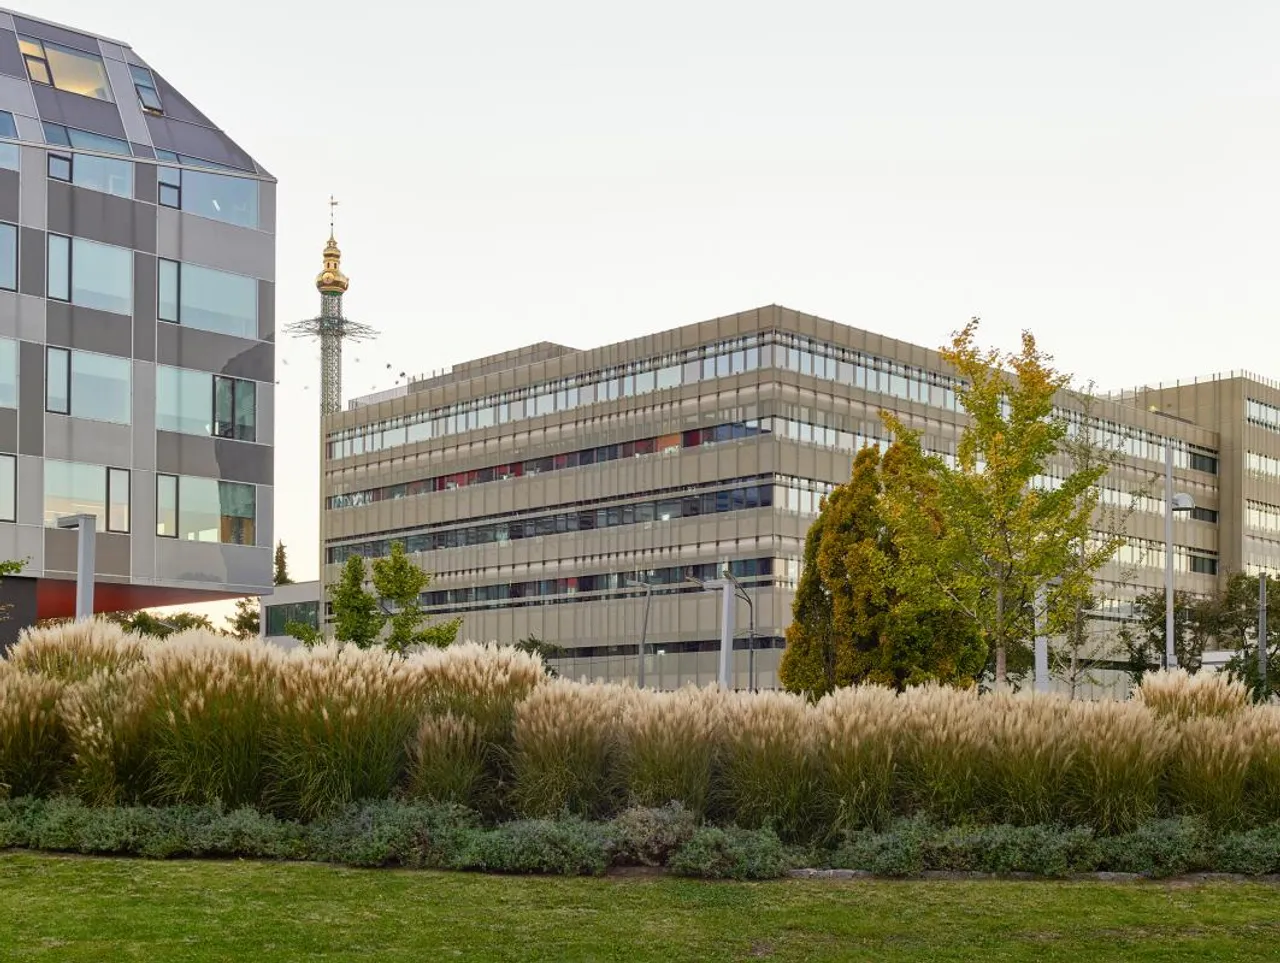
[35, 0, 1280, 578]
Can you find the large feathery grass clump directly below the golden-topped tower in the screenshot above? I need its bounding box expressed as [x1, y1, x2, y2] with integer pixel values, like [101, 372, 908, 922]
[266, 645, 424, 818]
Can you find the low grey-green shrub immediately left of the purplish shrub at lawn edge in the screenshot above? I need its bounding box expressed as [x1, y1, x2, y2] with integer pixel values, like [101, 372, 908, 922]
[457, 818, 613, 876]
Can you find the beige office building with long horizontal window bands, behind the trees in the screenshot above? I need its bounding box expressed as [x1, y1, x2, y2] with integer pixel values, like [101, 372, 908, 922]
[311, 306, 1280, 688]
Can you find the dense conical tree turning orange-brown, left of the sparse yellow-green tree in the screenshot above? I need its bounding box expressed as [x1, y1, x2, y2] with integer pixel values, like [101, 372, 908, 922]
[780, 446, 986, 697]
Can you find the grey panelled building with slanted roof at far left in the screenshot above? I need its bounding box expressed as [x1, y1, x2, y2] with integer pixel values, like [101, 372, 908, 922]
[0, 10, 275, 638]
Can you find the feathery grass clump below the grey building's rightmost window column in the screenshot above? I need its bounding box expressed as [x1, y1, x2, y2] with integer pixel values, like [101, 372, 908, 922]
[147, 629, 282, 807]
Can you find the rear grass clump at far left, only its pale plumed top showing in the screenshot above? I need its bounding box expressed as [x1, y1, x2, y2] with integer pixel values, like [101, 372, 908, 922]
[8, 619, 160, 683]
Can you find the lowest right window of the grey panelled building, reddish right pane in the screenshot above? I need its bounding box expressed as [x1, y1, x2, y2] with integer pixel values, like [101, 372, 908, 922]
[156, 475, 256, 546]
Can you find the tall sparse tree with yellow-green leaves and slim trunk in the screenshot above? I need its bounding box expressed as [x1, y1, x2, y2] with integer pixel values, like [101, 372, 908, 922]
[882, 318, 1106, 688]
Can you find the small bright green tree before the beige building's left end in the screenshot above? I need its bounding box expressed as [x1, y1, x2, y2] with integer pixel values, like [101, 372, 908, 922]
[325, 542, 462, 653]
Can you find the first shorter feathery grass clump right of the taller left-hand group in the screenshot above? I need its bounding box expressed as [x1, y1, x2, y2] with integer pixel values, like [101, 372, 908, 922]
[512, 679, 635, 817]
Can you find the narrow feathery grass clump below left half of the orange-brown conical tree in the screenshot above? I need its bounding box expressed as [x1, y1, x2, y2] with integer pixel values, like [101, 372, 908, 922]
[815, 686, 900, 832]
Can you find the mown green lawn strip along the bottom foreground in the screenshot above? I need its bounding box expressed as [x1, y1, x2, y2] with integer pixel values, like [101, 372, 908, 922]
[0, 853, 1280, 963]
